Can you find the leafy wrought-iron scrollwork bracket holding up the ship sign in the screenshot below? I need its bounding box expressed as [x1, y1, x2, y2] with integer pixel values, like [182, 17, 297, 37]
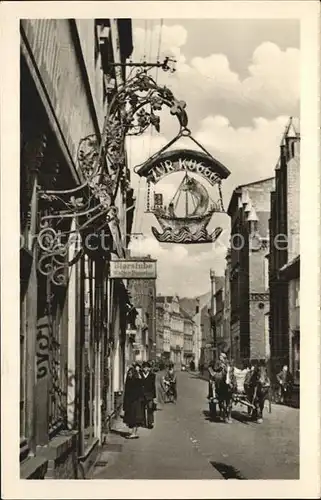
[38, 70, 188, 270]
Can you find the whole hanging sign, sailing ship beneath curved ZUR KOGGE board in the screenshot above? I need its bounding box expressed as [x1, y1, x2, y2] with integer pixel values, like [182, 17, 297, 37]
[137, 149, 230, 244]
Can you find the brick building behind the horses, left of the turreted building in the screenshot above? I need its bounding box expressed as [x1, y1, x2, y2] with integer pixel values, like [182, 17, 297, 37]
[228, 178, 274, 364]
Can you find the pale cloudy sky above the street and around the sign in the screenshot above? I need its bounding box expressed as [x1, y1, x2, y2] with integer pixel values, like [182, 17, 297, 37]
[124, 19, 300, 297]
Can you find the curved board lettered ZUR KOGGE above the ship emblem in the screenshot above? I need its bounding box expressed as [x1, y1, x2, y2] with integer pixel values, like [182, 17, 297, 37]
[137, 149, 230, 186]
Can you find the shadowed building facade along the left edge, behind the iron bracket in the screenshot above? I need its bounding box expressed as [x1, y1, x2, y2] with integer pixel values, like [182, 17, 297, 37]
[20, 19, 133, 479]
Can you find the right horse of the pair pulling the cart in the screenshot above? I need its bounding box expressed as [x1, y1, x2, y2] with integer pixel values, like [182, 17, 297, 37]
[244, 365, 270, 424]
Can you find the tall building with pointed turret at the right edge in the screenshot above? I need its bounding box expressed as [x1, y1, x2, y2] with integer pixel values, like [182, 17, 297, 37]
[269, 118, 300, 385]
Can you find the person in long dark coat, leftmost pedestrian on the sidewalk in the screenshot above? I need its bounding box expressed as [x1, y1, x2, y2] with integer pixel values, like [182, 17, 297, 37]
[124, 367, 144, 439]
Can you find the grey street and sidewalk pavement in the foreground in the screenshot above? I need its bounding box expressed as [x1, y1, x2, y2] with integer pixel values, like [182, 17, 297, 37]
[93, 372, 299, 480]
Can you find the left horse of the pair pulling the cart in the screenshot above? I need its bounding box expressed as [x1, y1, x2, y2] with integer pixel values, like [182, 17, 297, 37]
[210, 365, 235, 423]
